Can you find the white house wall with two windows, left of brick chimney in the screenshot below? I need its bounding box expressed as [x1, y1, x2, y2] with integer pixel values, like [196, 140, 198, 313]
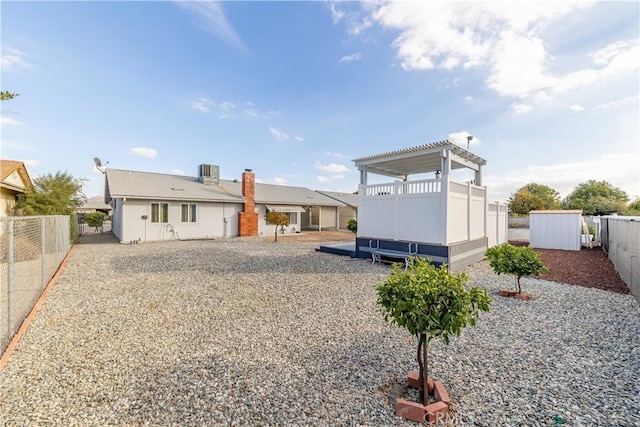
[112, 199, 242, 243]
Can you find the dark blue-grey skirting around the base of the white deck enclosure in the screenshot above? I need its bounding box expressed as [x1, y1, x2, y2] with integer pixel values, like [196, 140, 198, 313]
[355, 237, 489, 271]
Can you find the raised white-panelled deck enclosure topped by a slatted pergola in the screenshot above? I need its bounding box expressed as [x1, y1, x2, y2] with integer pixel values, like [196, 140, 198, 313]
[344, 141, 507, 270]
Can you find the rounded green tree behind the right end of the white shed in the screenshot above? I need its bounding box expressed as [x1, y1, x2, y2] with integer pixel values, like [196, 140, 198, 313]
[563, 179, 629, 215]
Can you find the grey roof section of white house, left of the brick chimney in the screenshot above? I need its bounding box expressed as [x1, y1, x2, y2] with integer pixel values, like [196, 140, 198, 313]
[105, 169, 244, 203]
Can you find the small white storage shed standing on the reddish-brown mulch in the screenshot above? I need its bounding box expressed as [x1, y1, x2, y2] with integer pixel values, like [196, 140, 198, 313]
[529, 211, 582, 251]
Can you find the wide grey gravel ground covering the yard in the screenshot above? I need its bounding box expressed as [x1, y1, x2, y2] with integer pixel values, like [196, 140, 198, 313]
[0, 235, 640, 427]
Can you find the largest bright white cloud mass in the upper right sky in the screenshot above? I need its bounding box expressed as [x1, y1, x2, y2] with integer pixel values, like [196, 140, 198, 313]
[361, 0, 640, 114]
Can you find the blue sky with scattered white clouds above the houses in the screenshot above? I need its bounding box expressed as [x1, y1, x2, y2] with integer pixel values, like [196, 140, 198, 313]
[0, 0, 640, 201]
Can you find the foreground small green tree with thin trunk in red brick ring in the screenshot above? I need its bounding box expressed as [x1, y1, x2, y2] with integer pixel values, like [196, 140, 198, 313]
[377, 258, 491, 405]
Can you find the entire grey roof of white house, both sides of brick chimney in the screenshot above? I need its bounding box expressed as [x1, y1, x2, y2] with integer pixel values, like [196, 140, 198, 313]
[105, 169, 344, 207]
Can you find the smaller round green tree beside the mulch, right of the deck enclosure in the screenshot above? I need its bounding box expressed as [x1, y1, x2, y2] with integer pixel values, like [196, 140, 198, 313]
[485, 243, 549, 293]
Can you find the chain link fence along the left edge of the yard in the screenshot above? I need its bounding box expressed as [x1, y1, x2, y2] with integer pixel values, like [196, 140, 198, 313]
[0, 215, 71, 354]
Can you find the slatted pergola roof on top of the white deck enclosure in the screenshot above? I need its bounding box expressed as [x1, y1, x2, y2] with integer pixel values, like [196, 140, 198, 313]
[352, 140, 487, 179]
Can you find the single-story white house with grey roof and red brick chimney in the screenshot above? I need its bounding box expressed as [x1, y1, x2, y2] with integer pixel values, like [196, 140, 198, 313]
[105, 165, 345, 242]
